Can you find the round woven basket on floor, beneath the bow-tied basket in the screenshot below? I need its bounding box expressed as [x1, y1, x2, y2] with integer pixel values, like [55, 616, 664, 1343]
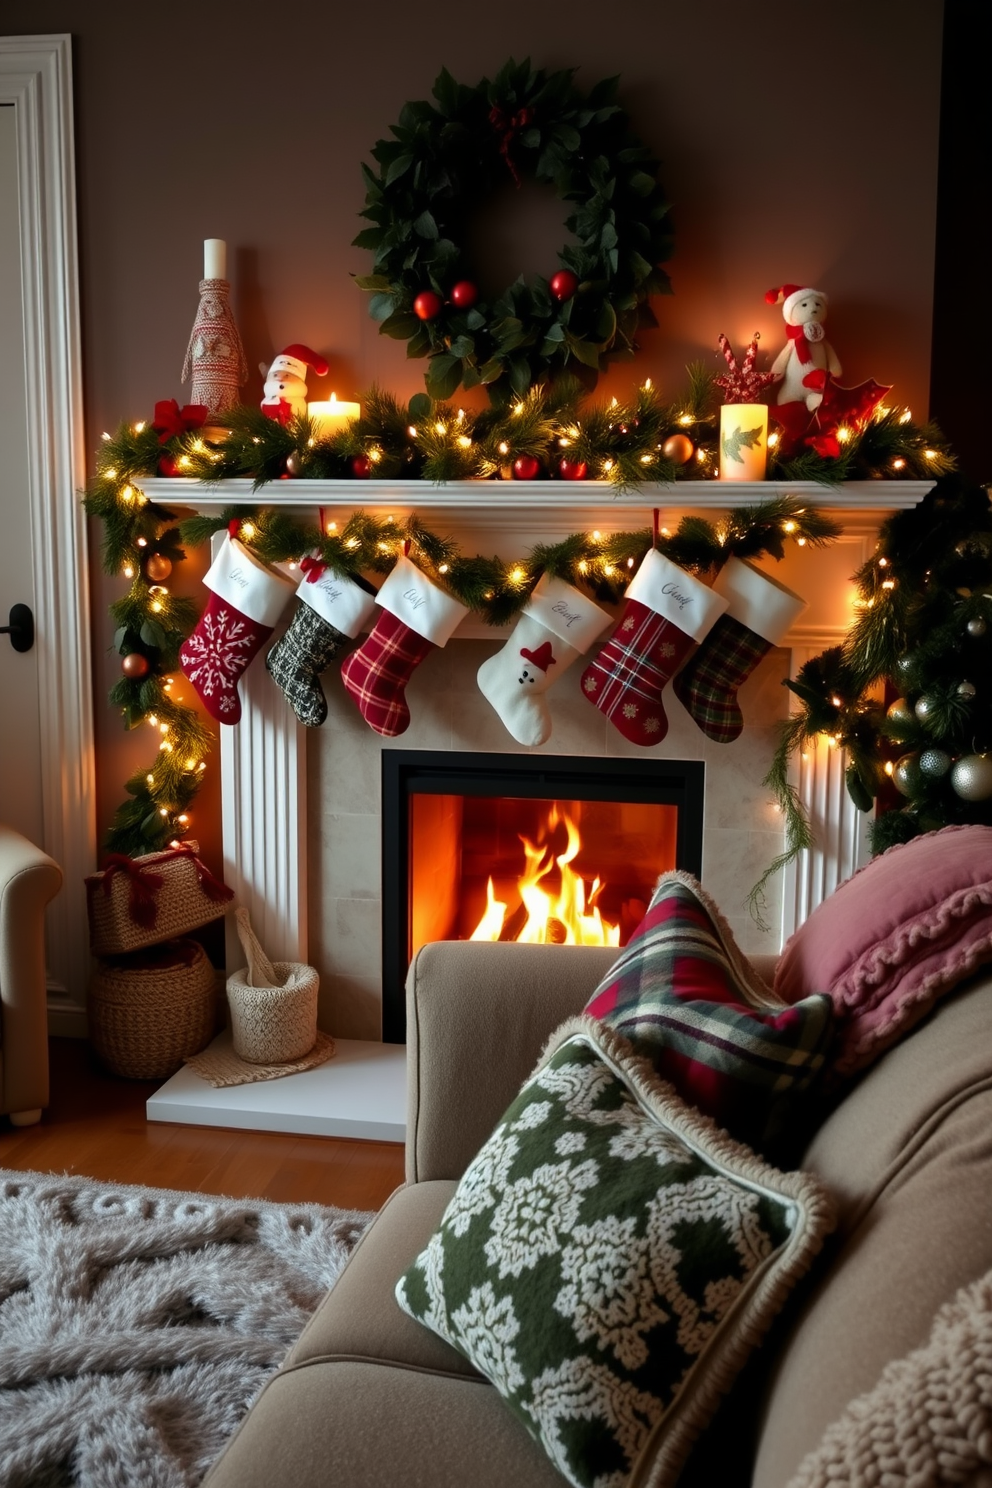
[88, 940, 219, 1080]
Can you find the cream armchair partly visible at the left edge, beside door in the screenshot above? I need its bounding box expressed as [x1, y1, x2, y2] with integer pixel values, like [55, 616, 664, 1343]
[0, 824, 62, 1126]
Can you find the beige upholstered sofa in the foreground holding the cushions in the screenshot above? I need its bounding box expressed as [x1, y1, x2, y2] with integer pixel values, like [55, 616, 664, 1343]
[207, 942, 992, 1488]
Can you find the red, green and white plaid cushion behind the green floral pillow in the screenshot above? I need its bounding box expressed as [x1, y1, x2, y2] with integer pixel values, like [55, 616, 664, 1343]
[586, 872, 833, 1146]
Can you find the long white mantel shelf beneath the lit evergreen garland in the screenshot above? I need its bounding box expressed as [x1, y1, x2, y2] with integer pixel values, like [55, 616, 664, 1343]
[138, 478, 934, 530]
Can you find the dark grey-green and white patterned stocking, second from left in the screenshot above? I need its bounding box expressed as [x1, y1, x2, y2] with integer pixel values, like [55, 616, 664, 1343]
[265, 561, 375, 728]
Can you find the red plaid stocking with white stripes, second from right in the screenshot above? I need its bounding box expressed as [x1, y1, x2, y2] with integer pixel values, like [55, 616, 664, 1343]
[582, 548, 727, 745]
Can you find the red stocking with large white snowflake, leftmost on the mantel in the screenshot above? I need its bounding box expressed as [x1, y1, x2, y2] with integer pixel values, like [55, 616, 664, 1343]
[178, 521, 294, 723]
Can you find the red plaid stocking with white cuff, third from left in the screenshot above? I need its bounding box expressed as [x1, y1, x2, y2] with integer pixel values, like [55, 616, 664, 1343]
[341, 557, 468, 738]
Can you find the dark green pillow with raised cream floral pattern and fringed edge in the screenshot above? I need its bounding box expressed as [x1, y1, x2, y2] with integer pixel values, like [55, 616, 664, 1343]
[396, 1018, 831, 1488]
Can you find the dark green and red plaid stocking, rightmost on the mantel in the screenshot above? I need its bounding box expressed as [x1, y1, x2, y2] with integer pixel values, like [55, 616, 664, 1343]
[672, 558, 806, 744]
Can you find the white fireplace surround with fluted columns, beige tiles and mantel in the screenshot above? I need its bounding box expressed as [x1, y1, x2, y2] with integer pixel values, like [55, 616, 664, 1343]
[144, 481, 930, 1040]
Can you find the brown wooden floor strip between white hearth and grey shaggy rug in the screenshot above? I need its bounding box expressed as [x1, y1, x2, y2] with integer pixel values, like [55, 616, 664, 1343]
[0, 1039, 403, 1210]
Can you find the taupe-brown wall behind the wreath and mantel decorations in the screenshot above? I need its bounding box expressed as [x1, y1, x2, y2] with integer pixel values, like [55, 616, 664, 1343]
[0, 0, 941, 863]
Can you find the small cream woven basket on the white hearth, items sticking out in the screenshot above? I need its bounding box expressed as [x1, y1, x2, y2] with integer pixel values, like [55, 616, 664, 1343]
[228, 909, 320, 1064]
